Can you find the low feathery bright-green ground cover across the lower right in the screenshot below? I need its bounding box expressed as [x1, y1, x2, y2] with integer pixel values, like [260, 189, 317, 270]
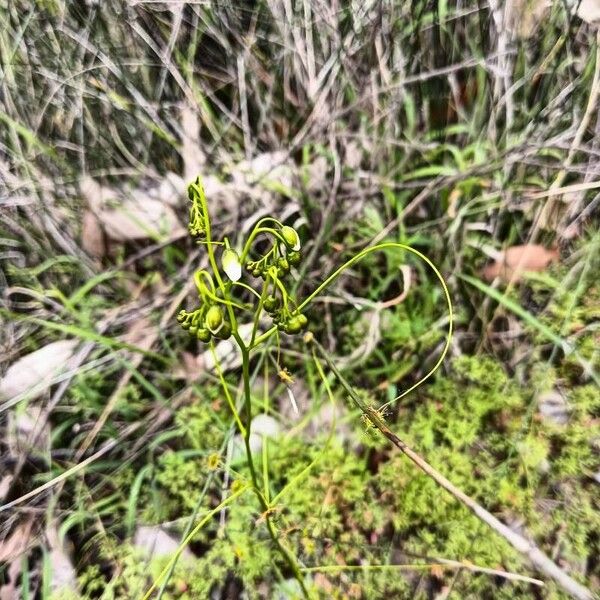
[72, 350, 600, 600]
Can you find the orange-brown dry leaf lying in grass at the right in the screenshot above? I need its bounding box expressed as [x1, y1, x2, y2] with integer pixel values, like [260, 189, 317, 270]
[482, 244, 558, 281]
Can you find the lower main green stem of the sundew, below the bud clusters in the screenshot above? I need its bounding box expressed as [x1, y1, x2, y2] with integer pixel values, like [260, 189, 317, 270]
[235, 342, 311, 598]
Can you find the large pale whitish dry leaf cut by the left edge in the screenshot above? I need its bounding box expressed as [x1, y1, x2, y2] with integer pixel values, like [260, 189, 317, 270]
[0, 340, 78, 400]
